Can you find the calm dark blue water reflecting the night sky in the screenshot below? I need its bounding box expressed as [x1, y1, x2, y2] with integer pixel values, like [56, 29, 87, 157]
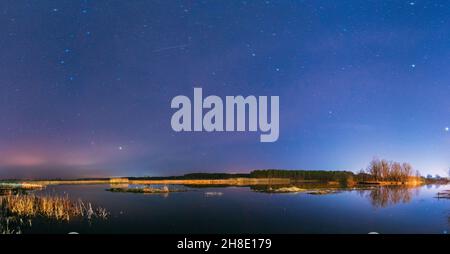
[19, 185, 450, 234]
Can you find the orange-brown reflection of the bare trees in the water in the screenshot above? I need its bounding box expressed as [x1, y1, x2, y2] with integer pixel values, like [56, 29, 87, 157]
[361, 186, 419, 208]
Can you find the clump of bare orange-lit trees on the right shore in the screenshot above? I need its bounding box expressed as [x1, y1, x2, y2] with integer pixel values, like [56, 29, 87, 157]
[360, 159, 420, 182]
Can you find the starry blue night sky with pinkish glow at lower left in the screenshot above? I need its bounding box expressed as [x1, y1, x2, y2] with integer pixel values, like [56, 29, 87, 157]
[0, 0, 450, 178]
